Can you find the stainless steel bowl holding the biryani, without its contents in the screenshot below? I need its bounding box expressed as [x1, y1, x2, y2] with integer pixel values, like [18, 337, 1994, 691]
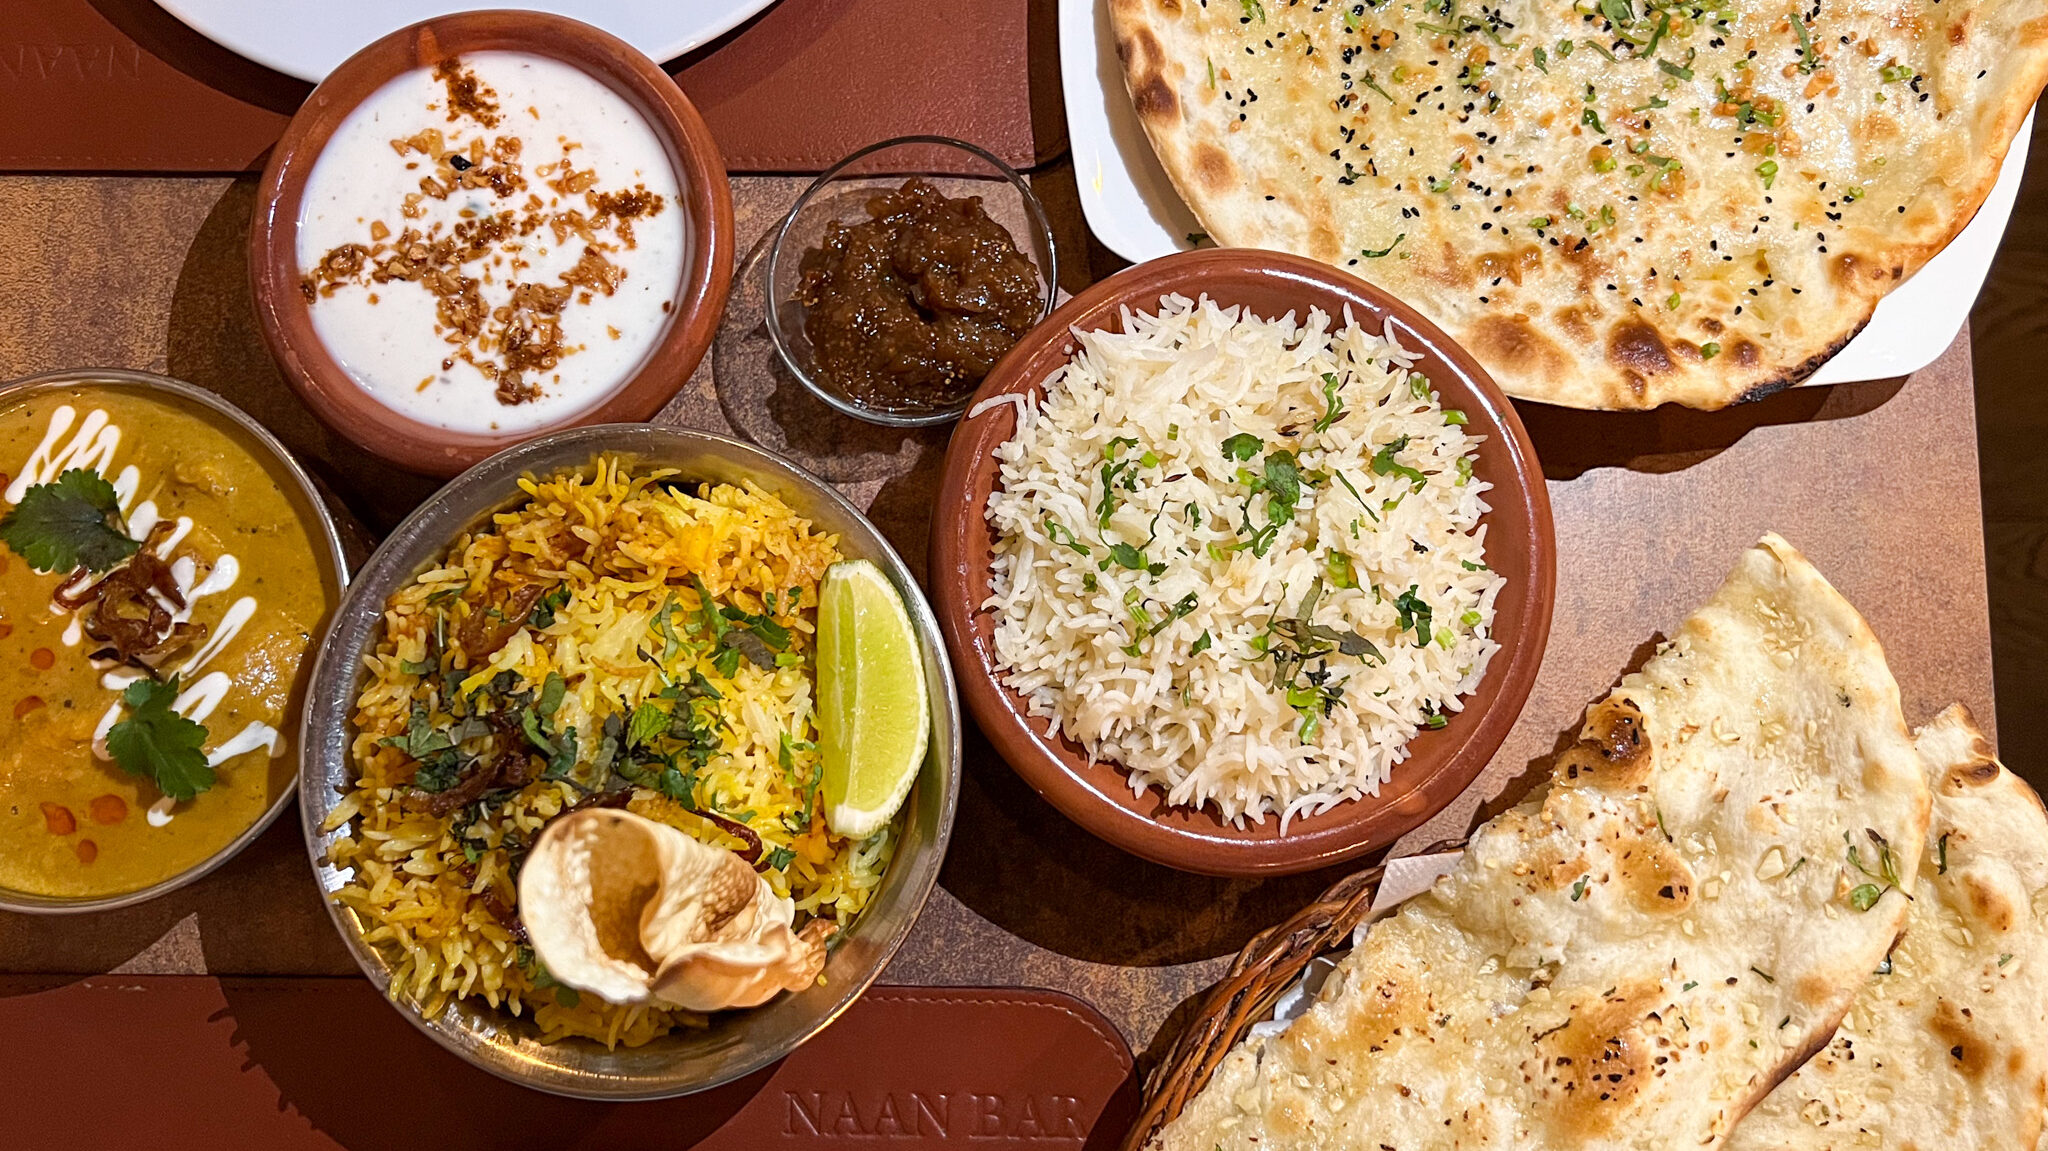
[299, 424, 961, 1100]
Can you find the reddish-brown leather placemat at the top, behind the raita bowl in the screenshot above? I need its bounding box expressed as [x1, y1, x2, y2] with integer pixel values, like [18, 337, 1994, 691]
[0, 0, 1065, 174]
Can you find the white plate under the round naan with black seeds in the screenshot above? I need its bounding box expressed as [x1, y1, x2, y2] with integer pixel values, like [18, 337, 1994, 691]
[1059, 0, 2034, 383]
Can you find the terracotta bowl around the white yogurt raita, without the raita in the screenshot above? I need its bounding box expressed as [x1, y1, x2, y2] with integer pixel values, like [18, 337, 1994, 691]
[250, 10, 733, 475]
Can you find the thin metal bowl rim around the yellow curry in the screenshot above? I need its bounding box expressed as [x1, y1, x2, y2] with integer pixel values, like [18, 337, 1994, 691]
[0, 369, 348, 915]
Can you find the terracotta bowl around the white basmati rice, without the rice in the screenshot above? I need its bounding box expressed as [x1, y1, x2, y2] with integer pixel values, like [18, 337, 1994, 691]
[930, 248, 1556, 875]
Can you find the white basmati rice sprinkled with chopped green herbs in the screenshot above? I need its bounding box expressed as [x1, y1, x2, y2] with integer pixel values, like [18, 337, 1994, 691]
[983, 295, 1503, 827]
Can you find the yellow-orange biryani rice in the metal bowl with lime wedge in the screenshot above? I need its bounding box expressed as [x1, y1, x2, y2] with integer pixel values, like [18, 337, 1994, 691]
[326, 459, 895, 1047]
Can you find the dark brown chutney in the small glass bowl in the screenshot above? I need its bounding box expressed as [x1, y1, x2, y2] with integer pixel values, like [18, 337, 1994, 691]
[797, 178, 1044, 408]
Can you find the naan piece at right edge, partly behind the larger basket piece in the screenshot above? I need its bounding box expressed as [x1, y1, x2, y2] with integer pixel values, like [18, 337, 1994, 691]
[1729, 705, 2048, 1151]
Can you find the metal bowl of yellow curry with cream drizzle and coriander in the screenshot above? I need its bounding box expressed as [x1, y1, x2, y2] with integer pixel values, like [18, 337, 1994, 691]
[0, 369, 346, 913]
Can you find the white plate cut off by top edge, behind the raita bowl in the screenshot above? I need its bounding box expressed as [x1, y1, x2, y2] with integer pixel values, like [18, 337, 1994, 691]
[158, 0, 774, 84]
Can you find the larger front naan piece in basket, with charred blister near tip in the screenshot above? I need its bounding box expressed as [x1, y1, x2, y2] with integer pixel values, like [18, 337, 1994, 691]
[1155, 535, 1927, 1151]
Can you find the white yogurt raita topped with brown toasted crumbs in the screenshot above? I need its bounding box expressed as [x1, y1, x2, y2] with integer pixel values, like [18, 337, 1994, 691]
[297, 51, 688, 434]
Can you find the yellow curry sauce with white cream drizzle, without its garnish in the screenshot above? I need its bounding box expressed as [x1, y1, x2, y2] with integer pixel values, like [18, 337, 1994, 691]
[0, 383, 338, 897]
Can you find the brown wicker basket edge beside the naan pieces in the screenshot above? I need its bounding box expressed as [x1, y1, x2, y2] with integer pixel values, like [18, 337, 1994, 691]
[1122, 840, 1464, 1151]
